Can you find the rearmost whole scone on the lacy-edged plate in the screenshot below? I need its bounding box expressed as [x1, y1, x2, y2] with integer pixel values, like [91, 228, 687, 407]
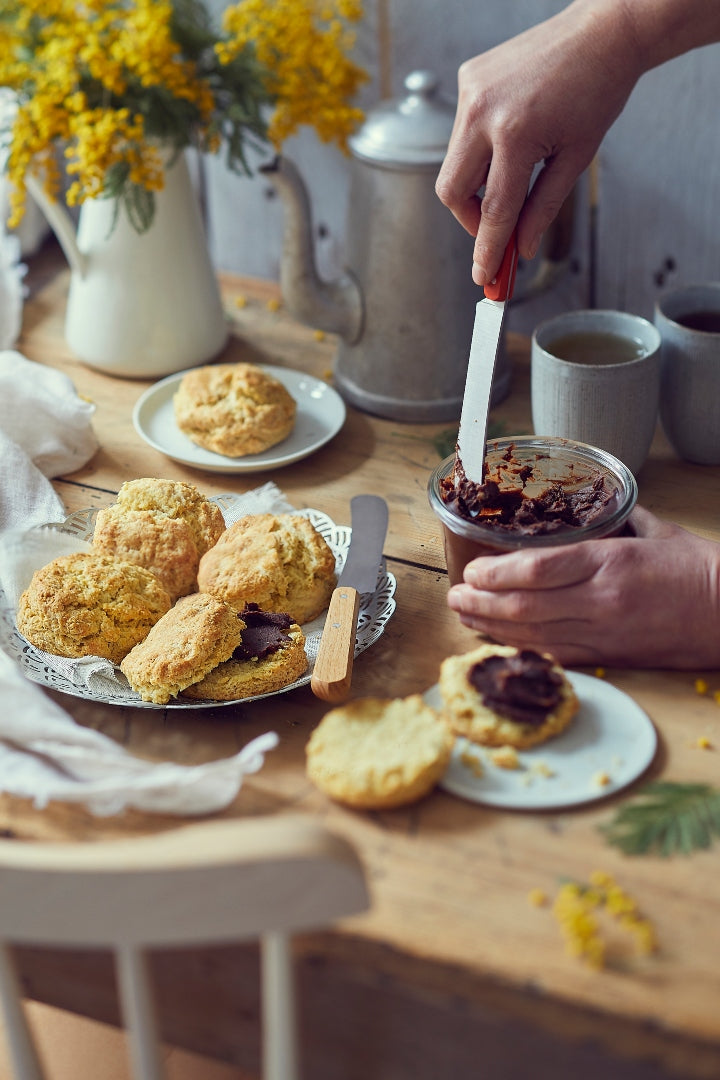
[93, 477, 226, 602]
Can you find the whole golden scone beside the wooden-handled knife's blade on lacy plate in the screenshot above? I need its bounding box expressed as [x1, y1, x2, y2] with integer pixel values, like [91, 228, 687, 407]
[198, 514, 336, 625]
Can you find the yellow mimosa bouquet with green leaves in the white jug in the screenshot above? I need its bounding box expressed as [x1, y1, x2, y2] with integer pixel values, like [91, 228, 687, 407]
[0, 0, 367, 225]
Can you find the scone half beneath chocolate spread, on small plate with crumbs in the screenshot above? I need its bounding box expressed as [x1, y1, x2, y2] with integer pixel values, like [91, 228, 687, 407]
[438, 645, 580, 750]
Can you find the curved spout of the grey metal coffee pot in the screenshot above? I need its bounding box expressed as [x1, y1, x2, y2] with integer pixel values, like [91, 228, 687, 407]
[261, 157, 363, 345]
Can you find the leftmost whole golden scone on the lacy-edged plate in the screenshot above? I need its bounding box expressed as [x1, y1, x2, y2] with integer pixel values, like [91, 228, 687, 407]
[17, 552, 171, 664]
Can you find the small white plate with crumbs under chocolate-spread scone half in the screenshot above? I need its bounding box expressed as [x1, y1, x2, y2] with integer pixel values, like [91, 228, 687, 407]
[424, 672, 657, 810]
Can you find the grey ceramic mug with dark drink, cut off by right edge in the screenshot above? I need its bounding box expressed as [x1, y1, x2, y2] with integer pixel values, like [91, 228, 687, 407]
[655, 282, 720, 465]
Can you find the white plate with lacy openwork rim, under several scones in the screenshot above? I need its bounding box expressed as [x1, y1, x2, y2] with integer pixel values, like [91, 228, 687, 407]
[0, 503, 396, 710]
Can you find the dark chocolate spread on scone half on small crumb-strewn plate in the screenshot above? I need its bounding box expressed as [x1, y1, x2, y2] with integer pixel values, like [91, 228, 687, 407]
[467, 649, 562, 724]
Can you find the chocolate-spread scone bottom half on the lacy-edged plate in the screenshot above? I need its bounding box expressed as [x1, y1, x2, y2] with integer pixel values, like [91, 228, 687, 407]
[182, 604, 308, 701]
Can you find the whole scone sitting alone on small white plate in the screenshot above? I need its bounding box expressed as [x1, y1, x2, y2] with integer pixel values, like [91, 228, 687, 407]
[173, 364, 297, 458]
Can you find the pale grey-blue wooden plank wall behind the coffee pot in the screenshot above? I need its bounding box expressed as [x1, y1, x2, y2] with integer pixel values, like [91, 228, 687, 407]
[204, 0, 720, 333]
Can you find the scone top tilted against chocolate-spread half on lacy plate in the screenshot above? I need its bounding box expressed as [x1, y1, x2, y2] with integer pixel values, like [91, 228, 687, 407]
[120, 593, 243, 705]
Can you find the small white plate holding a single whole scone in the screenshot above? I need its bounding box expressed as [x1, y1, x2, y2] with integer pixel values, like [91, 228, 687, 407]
[133, 364, 345, 473]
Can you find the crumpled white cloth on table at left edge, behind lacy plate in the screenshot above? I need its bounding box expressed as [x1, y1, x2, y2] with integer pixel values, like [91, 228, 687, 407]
[0, 349, 97, 529]
